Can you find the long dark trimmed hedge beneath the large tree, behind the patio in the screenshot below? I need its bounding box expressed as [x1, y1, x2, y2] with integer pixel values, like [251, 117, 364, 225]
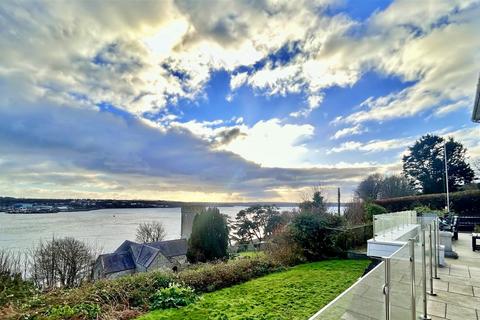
[374, 190, 480, 216]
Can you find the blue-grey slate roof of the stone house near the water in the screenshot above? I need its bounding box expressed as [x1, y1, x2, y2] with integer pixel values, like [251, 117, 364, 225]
[98, 239, 187, 274]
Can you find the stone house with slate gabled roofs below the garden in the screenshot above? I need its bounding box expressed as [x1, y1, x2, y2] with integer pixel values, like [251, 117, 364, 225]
[93, 239, 187, 280]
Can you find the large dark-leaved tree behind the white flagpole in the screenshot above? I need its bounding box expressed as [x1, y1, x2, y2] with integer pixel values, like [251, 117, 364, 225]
[403, 134, 475, 193]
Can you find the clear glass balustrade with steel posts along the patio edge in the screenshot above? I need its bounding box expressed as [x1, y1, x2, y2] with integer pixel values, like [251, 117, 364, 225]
[310, 213, 439, 320]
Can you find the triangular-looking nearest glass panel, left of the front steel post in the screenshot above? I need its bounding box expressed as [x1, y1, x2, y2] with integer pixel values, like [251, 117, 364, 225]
[313, 262, 385, 320]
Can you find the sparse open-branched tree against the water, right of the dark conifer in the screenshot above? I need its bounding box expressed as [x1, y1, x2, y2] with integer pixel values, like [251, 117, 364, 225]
[233, 205, 283, 243]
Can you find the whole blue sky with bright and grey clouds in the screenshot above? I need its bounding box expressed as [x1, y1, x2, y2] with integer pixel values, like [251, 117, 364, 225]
[0, 0, 480, 202]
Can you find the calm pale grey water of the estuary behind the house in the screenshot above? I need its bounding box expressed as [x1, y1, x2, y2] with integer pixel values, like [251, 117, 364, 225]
[0, 207, 300, 252]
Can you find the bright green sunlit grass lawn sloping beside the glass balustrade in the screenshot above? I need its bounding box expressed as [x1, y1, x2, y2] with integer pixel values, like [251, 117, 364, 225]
[139, 260, 369, 320]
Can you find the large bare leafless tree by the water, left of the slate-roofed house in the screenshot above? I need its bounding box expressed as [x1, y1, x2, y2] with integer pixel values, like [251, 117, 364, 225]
[30, 237, 95, 288]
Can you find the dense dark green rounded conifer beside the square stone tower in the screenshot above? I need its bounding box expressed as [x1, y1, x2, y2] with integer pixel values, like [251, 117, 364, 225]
[187, 208, 228, 263]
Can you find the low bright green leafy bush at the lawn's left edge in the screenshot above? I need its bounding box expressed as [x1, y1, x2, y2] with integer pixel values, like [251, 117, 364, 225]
[150, 283, 198, 310]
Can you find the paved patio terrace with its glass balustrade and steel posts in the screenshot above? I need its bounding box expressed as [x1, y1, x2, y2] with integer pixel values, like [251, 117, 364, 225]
[310, 211, 480, 320]
